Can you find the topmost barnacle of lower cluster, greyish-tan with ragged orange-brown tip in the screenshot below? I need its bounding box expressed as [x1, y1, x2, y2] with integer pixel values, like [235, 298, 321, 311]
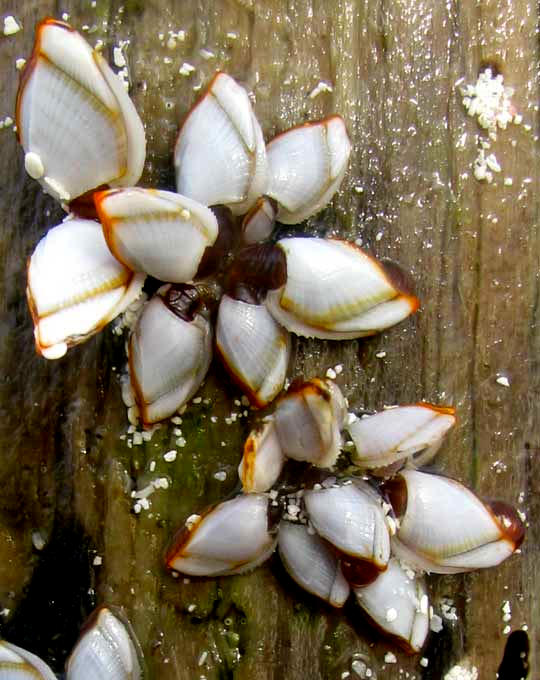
[274, 378, 346, 467]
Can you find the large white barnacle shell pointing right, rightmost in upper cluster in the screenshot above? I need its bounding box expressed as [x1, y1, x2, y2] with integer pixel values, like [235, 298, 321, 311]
[266, 237, 419, 340]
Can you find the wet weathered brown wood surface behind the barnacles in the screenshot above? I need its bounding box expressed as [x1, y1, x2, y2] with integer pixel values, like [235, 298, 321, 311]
[0, 0, 540, 680]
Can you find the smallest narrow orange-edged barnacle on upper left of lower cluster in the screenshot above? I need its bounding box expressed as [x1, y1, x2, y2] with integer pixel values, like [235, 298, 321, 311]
[238, 420, 285, 493]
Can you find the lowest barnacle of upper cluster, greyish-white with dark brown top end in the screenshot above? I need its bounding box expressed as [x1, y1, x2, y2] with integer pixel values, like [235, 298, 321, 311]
[128, 284, 212, 425]
